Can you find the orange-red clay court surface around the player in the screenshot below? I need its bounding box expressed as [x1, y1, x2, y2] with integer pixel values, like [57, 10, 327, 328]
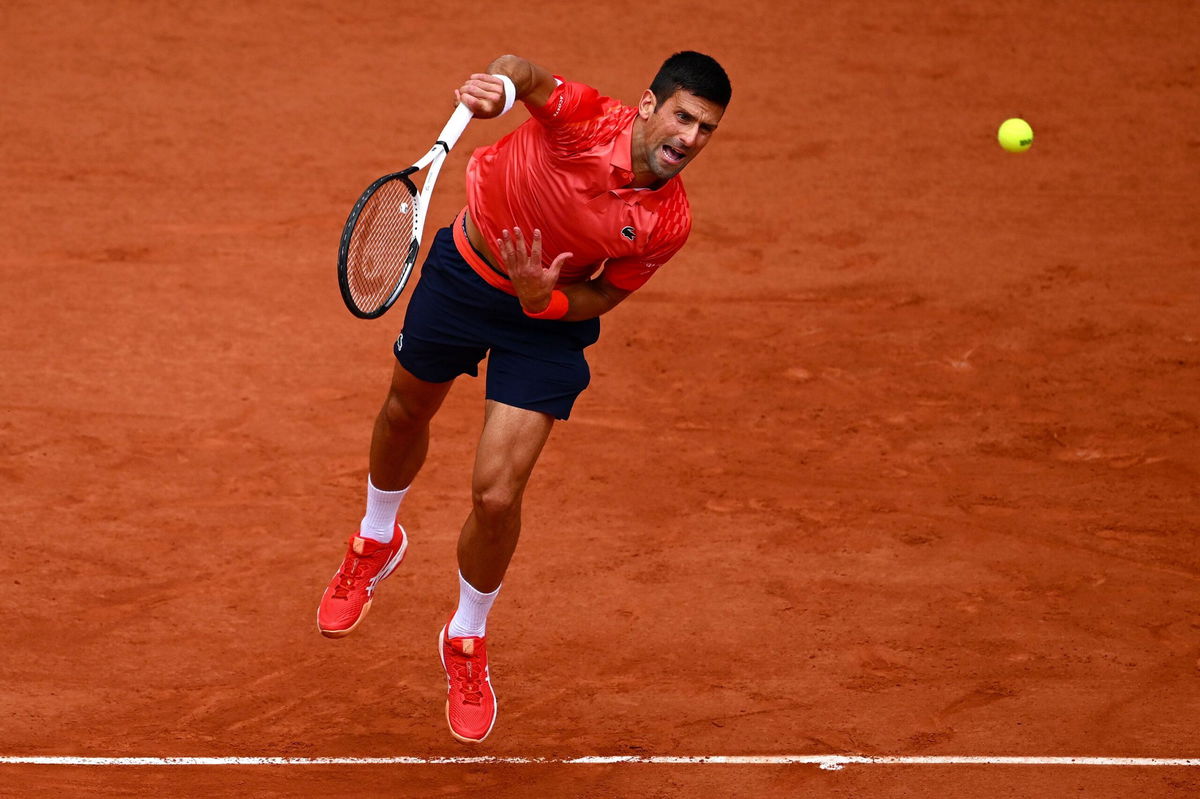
[0, 0, 1200, 798]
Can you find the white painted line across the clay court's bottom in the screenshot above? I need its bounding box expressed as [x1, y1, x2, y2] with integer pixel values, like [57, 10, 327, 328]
[0, 755, 1200, 771]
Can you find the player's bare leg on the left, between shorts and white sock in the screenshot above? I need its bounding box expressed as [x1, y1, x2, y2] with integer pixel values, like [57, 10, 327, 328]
[371, 362, 454, 491]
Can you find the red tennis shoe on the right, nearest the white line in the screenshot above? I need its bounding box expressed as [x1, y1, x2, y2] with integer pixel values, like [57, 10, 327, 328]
[438, 624, 496, 744]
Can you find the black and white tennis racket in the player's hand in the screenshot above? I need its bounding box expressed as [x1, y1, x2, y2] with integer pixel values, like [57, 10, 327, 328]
[337, 103, 472, 319]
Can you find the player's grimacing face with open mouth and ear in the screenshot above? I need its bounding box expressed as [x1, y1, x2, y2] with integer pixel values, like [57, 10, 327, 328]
[637, 89, 725, 180]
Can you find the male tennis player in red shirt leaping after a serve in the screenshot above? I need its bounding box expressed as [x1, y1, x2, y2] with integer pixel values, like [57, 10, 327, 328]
[317, 52, 731, 743]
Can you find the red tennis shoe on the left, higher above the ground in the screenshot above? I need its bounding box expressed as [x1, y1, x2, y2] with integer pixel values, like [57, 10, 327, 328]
[317, 524, 408, 638]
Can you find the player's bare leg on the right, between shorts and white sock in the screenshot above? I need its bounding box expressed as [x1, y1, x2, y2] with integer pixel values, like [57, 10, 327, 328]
[458, 401, 554, 594]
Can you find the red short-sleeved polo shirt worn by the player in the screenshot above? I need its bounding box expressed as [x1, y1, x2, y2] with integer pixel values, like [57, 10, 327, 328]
[455, 82, 691, 294]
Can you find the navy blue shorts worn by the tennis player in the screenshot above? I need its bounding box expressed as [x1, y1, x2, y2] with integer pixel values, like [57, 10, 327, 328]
[395, 221, 600, 419]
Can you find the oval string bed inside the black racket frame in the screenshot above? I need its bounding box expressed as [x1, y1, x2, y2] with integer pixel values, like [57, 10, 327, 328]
[346, 180, 416, 312]
